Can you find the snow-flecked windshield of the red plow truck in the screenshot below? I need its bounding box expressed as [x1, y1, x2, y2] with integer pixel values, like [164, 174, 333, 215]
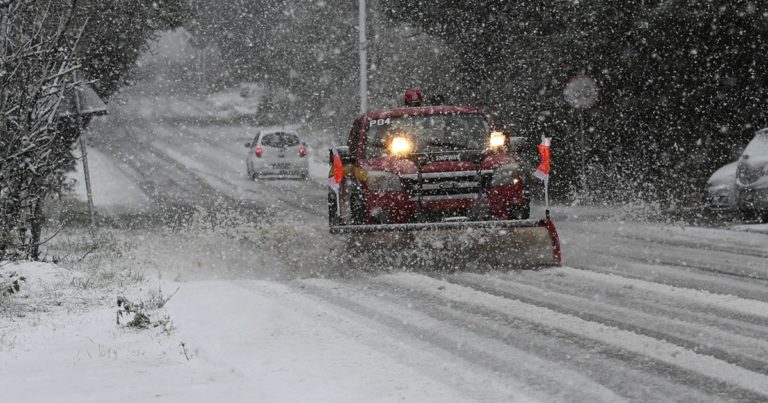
[365, 114, 490, 158]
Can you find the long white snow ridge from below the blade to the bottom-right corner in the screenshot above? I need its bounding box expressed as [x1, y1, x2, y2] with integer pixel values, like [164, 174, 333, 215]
[380, 273, 768, 400]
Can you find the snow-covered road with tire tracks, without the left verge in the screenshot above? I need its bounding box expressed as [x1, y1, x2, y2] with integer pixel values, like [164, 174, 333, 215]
[4, 115, 768, 402]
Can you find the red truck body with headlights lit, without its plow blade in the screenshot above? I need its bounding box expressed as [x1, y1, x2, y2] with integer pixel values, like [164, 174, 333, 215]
[328, 93, 530, 227]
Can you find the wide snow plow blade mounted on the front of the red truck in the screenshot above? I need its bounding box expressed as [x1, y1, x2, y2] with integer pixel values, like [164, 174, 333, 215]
[330, 217, 561, 267]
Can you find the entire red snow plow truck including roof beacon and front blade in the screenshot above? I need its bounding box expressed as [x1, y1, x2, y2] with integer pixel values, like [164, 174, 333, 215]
[328, 90, 560, 268]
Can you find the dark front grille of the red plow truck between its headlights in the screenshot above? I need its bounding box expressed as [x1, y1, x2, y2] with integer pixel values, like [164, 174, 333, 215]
[400, 170, 493, 201]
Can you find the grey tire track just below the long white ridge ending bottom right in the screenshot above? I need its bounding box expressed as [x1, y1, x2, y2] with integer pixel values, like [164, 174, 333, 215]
[364, 282, 732, 402]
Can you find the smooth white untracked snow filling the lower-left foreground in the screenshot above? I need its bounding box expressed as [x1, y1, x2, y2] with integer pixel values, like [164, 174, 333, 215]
[0, 263, 527, 402]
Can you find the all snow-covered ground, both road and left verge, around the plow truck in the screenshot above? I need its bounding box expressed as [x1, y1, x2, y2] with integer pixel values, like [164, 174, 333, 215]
[0, 93, 768, 402]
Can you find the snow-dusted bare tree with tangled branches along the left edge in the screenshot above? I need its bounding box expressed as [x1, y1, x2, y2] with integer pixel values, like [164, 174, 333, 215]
[0, 0, 187, 260]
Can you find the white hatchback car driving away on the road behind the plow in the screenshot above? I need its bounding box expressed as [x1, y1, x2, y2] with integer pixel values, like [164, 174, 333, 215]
[245, 130, 309, 179]
